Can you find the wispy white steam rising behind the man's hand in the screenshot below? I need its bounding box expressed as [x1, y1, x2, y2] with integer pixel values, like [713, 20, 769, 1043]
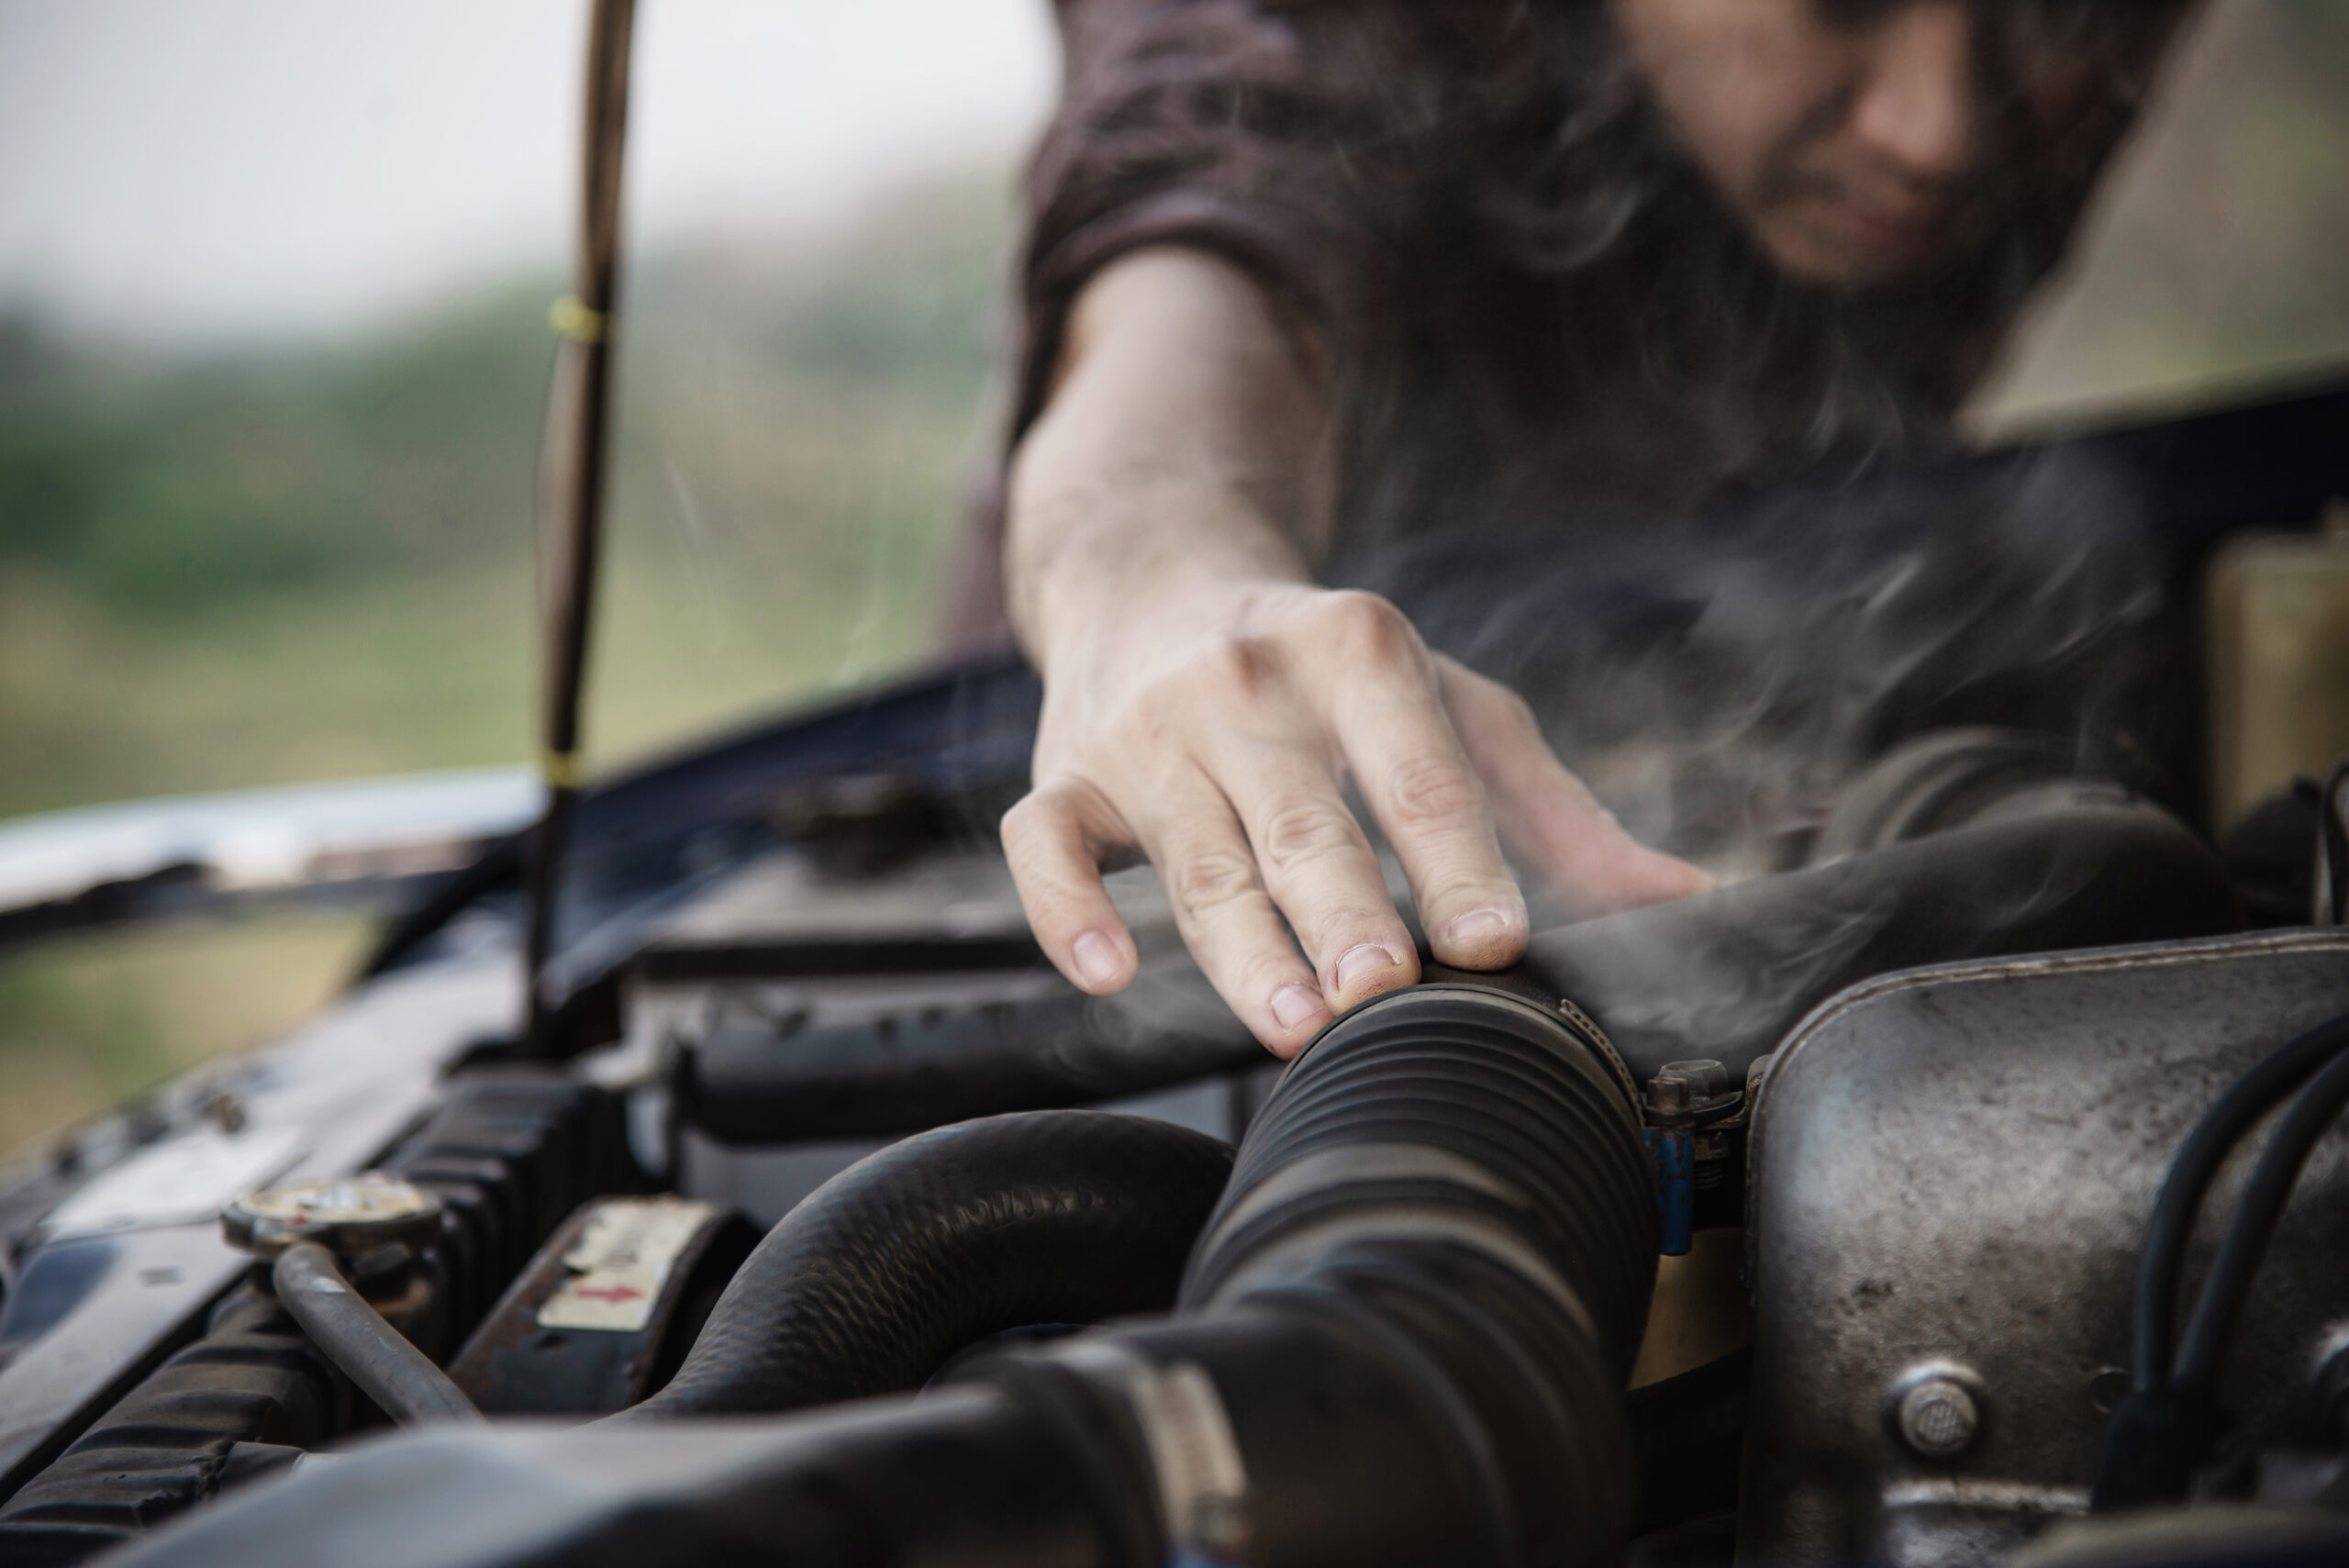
[1351, 440, 2182, 880]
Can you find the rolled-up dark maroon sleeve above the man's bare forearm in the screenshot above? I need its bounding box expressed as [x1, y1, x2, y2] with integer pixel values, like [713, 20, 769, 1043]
[1010, 0, 1482, 439]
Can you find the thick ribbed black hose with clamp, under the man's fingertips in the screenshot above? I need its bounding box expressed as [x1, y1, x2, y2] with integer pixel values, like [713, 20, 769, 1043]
[944, 984, 1656, 1568]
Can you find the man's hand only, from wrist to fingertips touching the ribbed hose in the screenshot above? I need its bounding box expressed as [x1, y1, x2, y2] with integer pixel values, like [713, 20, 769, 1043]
[1003, 582, 1706, 1056]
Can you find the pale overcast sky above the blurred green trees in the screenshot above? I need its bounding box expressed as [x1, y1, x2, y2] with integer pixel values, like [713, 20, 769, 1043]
[0, 0, 1057, 343]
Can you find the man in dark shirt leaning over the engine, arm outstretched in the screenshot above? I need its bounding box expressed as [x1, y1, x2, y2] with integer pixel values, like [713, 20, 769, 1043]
[965, 0, 2187, 1056]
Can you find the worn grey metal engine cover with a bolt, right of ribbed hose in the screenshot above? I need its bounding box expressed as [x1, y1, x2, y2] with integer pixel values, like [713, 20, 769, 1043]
[1738, 929, 2349, 1568]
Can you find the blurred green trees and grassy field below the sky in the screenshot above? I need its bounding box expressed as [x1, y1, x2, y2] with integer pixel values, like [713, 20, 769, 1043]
[0, 173, 1008, 815]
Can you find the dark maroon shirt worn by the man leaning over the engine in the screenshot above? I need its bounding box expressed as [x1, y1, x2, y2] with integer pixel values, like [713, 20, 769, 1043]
[949, 0, 2128, 643]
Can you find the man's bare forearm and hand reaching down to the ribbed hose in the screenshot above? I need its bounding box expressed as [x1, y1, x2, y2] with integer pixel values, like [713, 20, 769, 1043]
[1003, 251, 1706, 1056]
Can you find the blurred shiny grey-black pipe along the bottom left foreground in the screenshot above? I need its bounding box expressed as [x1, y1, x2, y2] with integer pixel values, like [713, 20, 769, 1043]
[110, 1390, 1127, 1568]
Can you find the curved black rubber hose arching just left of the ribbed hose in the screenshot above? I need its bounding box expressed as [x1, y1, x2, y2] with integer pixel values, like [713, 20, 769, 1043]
[618, 1110, 1230, 1420]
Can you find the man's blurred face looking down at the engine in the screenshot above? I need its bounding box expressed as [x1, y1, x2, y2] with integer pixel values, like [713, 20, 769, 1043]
[1609, 0, 2185, 289]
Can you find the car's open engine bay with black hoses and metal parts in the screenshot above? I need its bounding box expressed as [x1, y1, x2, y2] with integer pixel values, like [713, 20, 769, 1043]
[0, 392, 2349, 1568]
